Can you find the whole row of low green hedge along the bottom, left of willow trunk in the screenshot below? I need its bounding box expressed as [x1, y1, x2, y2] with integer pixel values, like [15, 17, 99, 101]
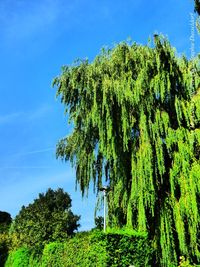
[5, 230, 152, 267]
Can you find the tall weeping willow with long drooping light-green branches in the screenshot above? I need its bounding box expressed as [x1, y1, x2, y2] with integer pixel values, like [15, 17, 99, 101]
[54, 36, 200, 266]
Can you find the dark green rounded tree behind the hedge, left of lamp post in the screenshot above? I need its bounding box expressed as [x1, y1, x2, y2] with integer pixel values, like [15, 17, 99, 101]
[12, 188, 80, 247]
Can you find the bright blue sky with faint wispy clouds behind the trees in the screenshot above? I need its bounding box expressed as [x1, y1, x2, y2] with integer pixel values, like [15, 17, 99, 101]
[0, 0, 200, 230]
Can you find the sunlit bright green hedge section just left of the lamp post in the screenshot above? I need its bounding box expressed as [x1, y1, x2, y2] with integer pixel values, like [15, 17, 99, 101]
[41, 232, 107, 267]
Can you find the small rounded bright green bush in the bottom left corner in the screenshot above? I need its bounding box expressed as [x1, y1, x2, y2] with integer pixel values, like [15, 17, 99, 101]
[5, 247, 31, 267]
